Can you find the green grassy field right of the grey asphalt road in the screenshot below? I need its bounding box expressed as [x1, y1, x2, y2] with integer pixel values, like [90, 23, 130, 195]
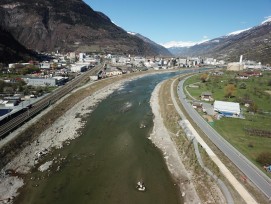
[185, 69, 271, 172]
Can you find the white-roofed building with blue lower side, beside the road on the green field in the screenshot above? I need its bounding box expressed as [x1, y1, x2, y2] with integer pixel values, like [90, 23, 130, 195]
[214, 101, 241, 117]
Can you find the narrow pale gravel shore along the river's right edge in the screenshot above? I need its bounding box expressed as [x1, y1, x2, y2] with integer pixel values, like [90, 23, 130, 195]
[150, 82, 201, 203]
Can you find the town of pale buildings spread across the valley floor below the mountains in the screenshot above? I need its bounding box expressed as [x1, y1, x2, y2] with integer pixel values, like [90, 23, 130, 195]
[0, 52, 270, 123]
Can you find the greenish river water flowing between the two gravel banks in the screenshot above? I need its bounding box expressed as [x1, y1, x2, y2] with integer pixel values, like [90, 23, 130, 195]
[15, 72, 188, 204]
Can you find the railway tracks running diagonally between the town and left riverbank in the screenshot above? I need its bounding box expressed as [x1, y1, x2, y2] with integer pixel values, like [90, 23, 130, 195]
[0, 65, 101, 139]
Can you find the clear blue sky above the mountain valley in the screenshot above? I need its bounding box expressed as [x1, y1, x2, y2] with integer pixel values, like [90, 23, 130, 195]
[84, 0, 271, 47]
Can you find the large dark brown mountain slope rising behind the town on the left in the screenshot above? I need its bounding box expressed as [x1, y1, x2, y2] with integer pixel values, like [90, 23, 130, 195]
[0, 0, 170, 56]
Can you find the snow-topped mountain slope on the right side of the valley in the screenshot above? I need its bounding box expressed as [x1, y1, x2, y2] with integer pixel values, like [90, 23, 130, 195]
[169, 19, 271, 64]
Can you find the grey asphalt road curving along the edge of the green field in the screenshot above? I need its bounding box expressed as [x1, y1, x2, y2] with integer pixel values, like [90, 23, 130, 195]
[178, 79, 271, 198]
